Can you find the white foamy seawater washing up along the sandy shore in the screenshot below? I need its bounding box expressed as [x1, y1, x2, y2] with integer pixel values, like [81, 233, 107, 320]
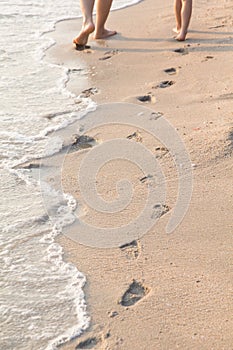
[0, 0, 140, 350]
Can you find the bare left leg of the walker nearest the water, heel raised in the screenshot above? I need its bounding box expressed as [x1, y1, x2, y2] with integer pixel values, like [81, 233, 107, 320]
[73, 0, 95, 46]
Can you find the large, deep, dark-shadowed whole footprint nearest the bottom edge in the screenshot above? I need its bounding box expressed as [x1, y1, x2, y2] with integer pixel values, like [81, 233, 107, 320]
[119, 280, 149, 306]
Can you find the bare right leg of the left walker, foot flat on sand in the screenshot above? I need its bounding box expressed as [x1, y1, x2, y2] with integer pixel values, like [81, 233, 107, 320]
[93, 0, 116, 39]
